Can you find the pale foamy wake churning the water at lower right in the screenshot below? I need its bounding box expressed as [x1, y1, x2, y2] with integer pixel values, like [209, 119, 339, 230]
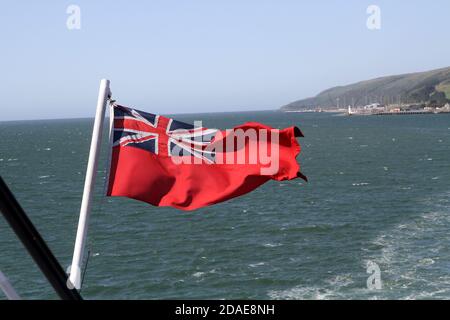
[364, 193, 450, 299]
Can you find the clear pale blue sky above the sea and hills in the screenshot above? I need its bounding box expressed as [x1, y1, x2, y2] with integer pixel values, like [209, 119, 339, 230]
[0, 0, 450, 121]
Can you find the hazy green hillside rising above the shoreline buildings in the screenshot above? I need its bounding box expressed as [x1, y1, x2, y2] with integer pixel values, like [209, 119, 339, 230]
[281, 67, 450, 111]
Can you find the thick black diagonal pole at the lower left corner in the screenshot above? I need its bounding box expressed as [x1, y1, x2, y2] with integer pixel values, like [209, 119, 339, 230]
[0, 177, 82, 300]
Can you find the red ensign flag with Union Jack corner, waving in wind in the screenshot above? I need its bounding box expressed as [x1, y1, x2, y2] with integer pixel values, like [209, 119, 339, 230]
[107, 105, 306, 210]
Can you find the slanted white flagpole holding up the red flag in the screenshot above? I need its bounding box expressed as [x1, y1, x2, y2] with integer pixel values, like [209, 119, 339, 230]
[67, 79, 110, 289]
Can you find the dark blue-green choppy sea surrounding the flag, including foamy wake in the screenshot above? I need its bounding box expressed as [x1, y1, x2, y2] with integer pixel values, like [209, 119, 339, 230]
[0, 112, 450, 299]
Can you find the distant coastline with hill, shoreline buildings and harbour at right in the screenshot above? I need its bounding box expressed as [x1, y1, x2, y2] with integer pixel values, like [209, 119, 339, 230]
[280, 67, 450, 115]
